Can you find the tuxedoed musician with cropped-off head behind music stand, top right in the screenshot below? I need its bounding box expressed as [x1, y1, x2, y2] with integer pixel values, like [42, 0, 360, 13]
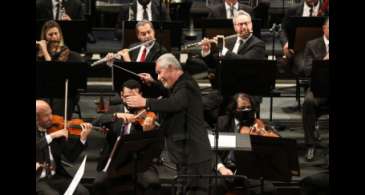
[280, 0, 321, 75]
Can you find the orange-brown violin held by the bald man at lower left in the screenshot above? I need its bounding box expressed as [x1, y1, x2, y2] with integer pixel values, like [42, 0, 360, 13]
[47, 115, 108, 136]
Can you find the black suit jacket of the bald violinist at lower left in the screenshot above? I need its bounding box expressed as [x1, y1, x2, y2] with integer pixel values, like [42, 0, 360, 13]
[36, 130, 86, 180]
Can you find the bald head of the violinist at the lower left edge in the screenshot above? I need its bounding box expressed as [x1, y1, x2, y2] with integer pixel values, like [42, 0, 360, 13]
[36, 100, 52, 129]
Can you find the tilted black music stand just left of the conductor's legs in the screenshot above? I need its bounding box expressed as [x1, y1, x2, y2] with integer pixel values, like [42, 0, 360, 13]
[107, 130, 164, 194]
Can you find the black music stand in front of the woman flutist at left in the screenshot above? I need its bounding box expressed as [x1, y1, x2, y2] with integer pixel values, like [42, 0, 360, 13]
[36, 61, 89, 99]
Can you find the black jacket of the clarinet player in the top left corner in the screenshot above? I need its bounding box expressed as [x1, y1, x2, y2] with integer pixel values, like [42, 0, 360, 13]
[36, 0, 85, 20]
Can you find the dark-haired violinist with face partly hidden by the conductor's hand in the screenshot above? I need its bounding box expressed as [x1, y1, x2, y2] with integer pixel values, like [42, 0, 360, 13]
[93, 79, 156, 195]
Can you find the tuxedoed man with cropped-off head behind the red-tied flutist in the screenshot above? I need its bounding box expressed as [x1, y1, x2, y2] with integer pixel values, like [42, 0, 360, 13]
[115, 0, 171, 40]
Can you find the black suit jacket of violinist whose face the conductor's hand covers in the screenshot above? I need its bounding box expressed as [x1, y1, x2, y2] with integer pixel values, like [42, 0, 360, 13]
[93, 104, 143, 171]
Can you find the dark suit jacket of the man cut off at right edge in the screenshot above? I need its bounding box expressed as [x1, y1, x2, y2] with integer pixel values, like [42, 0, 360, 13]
[304, 37, 327, 76]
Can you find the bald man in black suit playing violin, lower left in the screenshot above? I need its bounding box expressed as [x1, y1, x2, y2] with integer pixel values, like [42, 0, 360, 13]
[36, 100, 92, 195]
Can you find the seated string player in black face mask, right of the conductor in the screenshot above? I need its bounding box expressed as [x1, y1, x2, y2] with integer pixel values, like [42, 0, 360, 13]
[213, 93, 279, 194]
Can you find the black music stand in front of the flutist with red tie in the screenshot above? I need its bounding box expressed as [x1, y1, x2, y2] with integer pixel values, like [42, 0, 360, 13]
[112, 61, 160, 98]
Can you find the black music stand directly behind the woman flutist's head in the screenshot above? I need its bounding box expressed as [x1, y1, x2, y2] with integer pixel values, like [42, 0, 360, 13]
[35, 20, 88, 53]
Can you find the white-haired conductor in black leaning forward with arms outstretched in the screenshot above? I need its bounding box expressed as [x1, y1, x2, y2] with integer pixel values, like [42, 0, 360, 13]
[126, 53, 211, 195]
